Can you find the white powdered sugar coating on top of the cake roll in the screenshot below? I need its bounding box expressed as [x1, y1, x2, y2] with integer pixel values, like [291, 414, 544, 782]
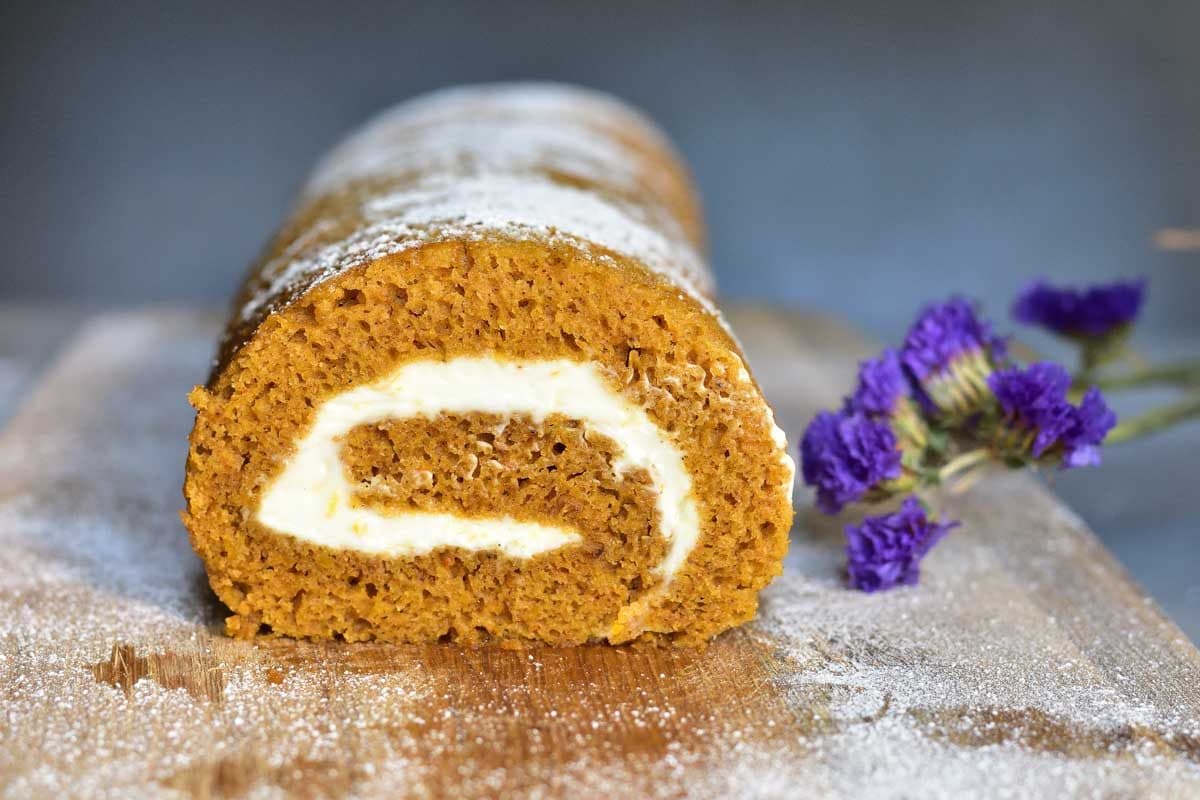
[239, 84, 716, 338]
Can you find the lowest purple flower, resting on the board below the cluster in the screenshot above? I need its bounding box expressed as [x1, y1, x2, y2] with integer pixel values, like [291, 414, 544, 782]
[846, 497, 959, 591]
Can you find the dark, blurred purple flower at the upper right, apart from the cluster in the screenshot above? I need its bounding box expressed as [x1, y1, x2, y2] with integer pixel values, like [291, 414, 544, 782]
[1013, 281, 1146, 337]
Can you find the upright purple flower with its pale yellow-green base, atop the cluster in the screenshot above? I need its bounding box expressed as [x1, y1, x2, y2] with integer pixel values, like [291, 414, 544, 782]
[900, 297, 1007, 416]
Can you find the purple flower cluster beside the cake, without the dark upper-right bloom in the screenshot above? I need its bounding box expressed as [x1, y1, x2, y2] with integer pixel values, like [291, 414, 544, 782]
[800, 284, 1123, 591]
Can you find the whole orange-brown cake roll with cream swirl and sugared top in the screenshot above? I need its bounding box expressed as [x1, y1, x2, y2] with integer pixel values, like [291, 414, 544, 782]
[182, 84, 793, 645]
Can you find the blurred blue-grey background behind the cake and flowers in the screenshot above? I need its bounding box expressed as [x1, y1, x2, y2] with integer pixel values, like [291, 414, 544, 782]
[0, 0, 1200, 638]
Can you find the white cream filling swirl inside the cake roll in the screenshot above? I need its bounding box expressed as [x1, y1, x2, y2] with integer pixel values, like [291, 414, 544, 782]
[257, 356, 700, 579]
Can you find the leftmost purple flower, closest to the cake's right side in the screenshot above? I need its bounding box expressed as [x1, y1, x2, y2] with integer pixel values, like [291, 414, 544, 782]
[800, 411, 900, 513]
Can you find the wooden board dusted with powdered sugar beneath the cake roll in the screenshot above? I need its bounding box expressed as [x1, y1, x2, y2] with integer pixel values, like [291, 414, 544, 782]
[0, 308, 1200, 799]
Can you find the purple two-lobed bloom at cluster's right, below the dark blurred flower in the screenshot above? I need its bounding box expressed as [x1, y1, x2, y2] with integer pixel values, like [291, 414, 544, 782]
[988, 362, 1117, 468]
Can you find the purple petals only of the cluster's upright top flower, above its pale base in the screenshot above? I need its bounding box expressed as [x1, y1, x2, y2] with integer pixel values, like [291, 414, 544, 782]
[901, 297, 1007, 381]
